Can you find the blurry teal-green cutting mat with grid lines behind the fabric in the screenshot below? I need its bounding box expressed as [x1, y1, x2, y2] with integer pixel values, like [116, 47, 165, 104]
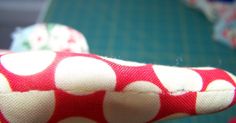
[44, 0, 236, 123]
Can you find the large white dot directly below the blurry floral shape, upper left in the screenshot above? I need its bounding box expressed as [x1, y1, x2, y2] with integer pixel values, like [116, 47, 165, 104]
[0, 51, 56, 75]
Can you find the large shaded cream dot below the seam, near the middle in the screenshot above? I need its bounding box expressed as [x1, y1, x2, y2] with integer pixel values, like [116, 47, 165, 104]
[103, 92, 160, 123]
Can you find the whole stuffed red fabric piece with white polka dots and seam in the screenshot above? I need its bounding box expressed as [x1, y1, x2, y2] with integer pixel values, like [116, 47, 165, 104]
[0, 51, 236, 123]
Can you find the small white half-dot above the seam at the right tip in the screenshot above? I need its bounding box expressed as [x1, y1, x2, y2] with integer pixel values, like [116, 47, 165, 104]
[206, 80, 235, 91]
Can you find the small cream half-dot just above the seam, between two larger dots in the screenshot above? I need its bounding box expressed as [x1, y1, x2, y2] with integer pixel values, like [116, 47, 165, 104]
[124, 81, 161, 93]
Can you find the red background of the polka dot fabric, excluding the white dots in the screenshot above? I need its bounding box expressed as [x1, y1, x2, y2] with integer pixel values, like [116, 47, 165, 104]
[0, 53, 236, 123]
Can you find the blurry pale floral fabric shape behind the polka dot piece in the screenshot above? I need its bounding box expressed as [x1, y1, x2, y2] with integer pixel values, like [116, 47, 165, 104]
[10, 23, 89, 53]
